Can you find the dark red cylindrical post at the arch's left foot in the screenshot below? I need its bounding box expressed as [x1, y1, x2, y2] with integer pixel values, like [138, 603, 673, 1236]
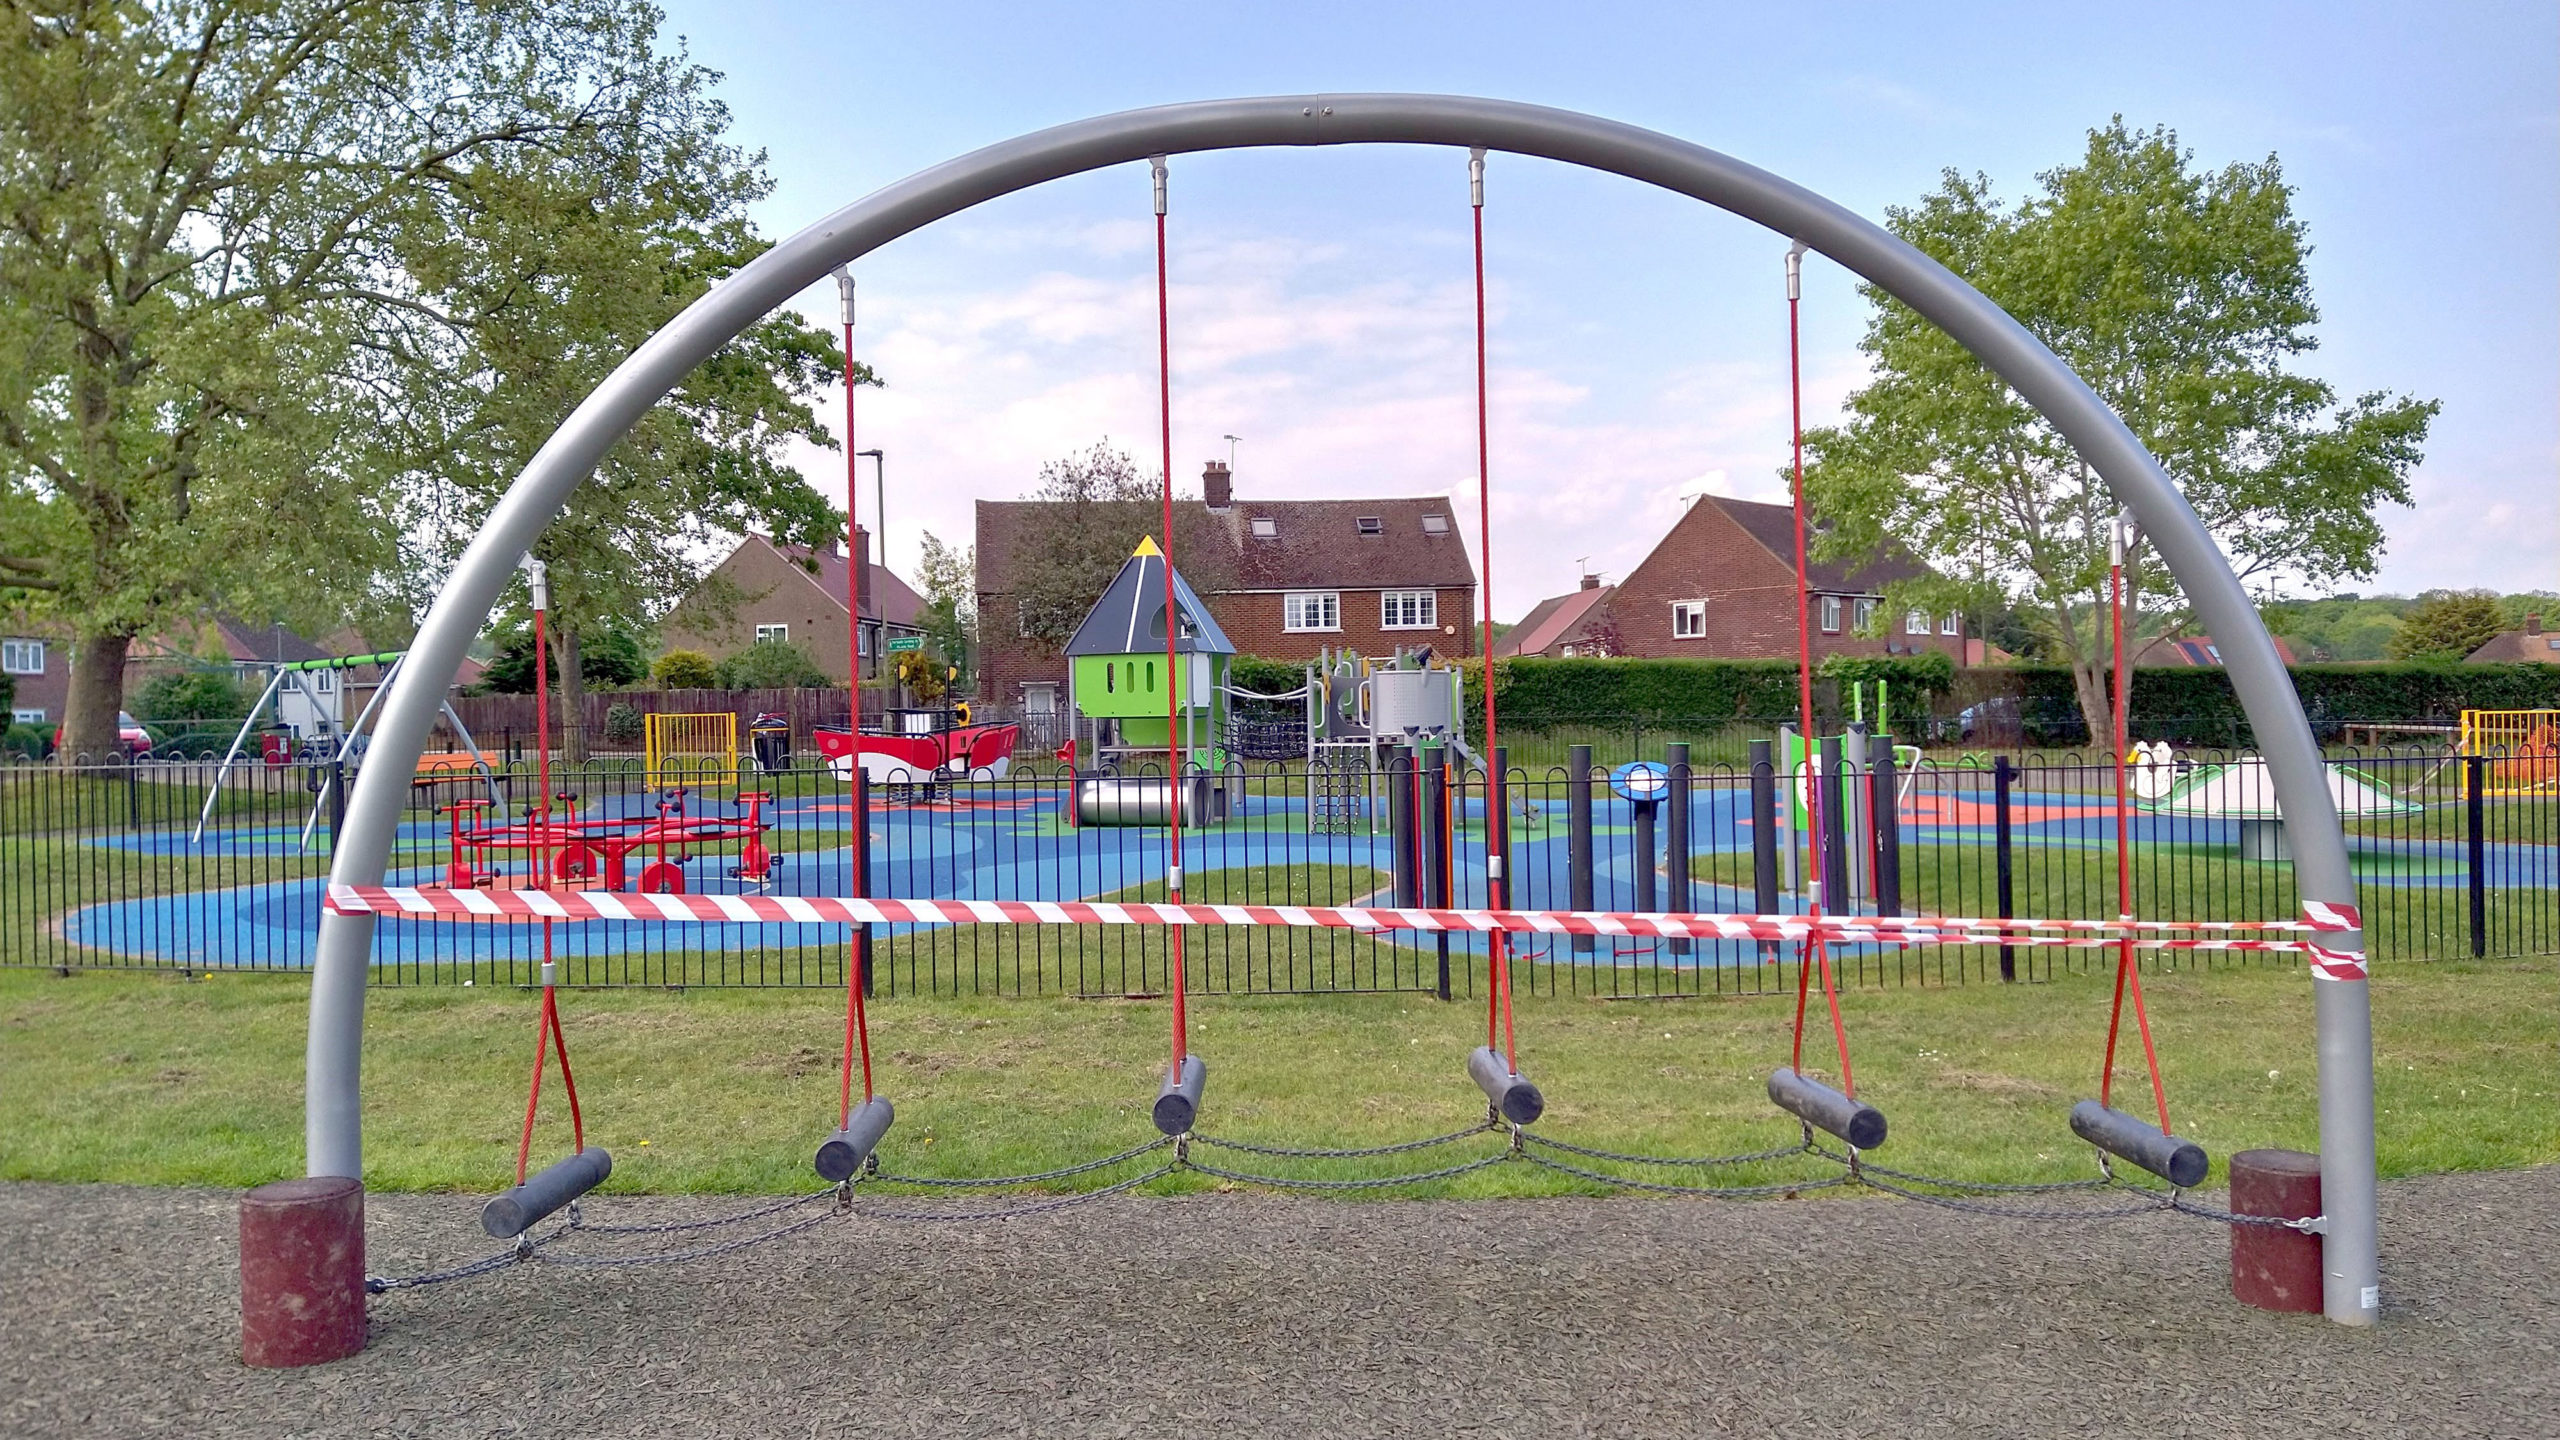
[241, 1176, 364, 1368]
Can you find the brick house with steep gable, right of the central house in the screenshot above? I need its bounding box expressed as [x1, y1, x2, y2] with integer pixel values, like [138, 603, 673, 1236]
[1495, 495, 1974, 664]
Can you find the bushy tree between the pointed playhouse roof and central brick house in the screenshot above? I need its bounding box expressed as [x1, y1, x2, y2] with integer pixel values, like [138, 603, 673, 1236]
[1011, 441, 1236, 646]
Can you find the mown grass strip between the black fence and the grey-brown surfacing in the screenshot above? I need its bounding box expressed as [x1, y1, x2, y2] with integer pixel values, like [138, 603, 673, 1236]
[0, 958, 2560, 1194]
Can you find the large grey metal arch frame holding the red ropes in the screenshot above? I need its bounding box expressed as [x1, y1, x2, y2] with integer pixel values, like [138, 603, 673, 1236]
[305, 95, 2378, 1325]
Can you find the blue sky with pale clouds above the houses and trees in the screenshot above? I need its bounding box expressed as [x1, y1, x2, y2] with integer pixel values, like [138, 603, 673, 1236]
[668, 3, 2560, 620]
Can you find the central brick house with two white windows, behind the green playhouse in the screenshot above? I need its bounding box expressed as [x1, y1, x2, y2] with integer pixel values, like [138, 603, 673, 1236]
[975, 461, 1477, 715]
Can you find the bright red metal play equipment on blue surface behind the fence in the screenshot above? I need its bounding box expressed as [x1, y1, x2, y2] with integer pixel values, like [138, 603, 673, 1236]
[445, 789, 783, 894]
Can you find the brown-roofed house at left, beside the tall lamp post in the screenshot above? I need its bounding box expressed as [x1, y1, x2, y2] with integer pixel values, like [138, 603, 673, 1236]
[658, 528, 924, 684]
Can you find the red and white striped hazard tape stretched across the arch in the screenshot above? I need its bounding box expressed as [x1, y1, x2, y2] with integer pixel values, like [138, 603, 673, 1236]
[328, 884, 2363, 958]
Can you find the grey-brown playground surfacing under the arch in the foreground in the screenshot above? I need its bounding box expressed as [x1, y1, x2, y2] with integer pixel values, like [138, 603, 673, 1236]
[0, 1171, 2560, 1440]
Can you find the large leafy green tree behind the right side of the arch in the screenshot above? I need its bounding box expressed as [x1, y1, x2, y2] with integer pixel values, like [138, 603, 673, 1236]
[1805, 118, 2437, 735]
